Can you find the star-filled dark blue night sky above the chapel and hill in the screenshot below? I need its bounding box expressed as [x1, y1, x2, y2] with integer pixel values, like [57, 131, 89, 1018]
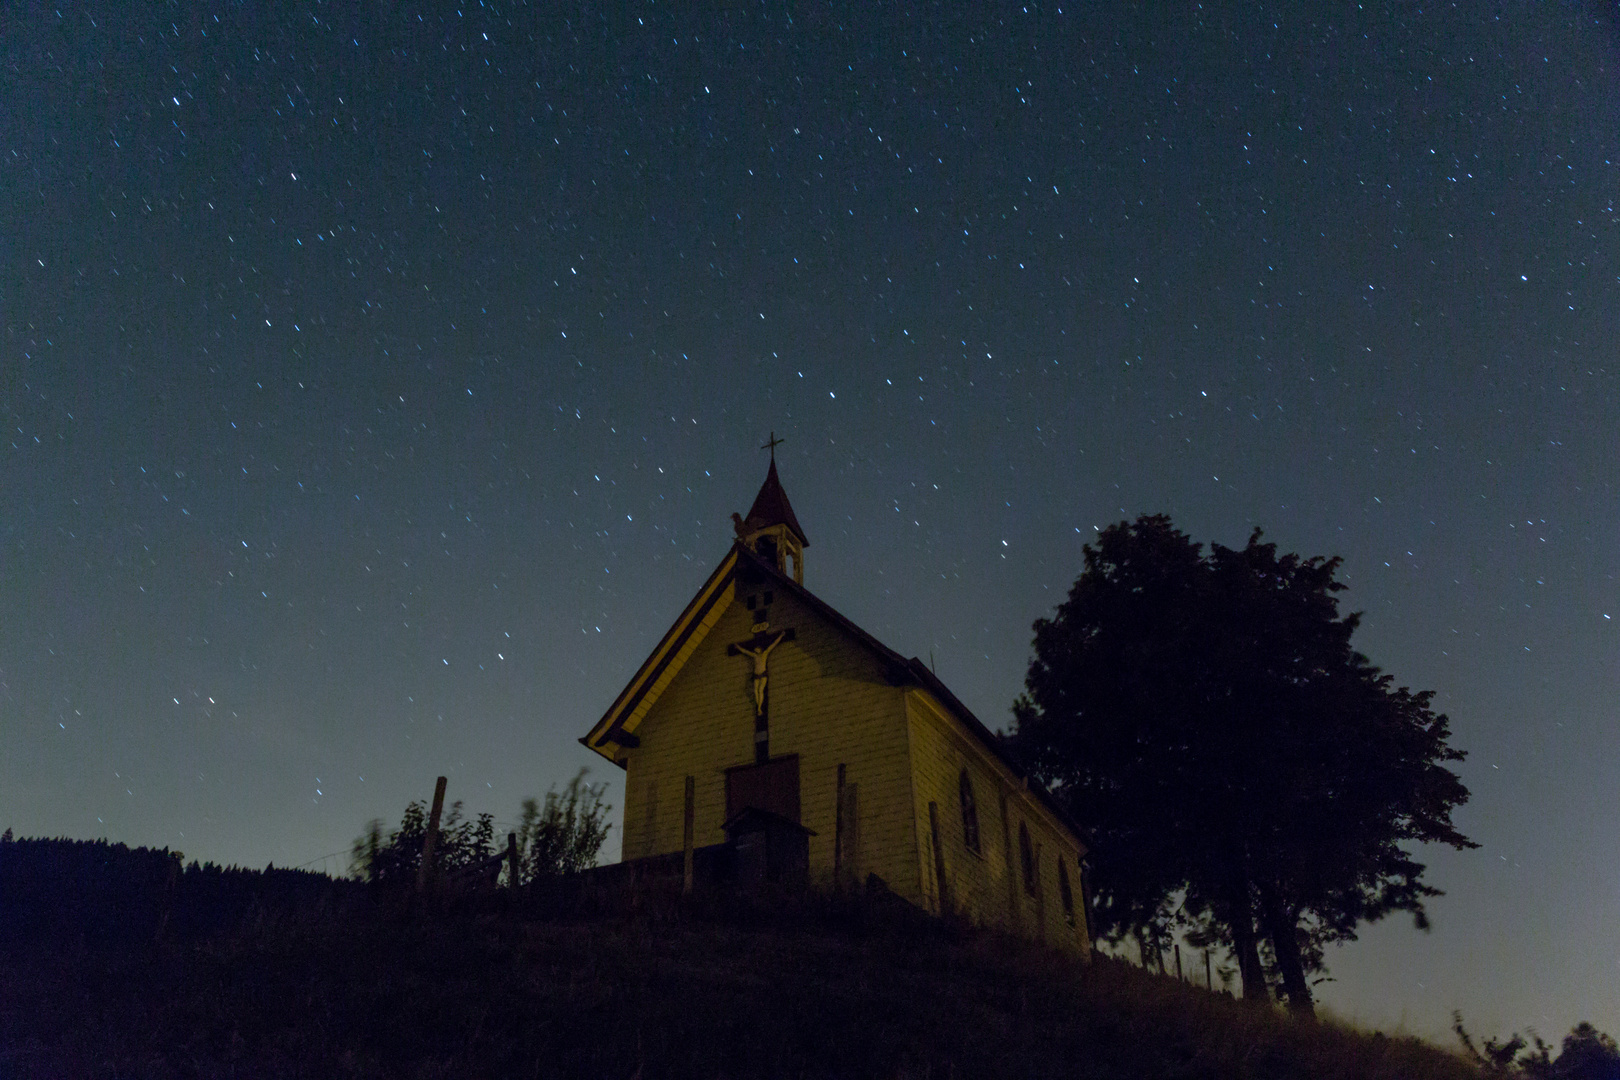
[0, 2, 1620, 1038]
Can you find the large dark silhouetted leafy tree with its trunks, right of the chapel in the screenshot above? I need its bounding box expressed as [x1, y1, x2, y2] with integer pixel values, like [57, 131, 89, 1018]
[1013, 515, 1474, 1012]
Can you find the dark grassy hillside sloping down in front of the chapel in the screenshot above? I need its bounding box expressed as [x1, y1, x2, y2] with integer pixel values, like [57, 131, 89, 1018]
[0, 845, 1477, 1080]
